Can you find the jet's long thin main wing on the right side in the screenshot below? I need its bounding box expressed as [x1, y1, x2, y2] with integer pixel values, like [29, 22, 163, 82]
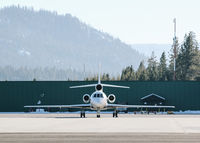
[107, 104, 175, 108]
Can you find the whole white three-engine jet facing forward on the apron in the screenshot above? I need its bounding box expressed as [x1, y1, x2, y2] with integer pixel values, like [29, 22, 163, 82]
[24, 71, 175, 118]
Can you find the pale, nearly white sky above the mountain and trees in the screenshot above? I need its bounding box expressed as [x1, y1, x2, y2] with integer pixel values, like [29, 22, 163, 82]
[0, 0, 200, 44]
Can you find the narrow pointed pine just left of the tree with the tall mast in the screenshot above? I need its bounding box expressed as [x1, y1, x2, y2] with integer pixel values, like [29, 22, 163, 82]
[158, 52, 167, 81]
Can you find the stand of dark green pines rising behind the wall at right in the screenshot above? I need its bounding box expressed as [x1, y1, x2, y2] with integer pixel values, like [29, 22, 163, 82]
[121, 32, 200, 81]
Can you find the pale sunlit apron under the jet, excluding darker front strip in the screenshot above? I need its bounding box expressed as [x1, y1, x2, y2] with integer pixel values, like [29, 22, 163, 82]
[0, 114, 200, 133]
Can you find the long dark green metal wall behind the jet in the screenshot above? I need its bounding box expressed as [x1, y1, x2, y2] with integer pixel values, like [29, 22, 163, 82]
[0, 81, 200, 112]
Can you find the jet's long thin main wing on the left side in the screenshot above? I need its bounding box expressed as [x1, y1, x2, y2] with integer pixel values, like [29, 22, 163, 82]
[24, 104, 90, 108]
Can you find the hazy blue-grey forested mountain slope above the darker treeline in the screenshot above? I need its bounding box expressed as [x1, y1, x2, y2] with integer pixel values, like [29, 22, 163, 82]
[0, 6, 145, 80]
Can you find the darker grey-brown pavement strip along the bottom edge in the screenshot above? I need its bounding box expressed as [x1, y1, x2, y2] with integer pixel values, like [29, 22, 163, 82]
[0, 133, 200, 143]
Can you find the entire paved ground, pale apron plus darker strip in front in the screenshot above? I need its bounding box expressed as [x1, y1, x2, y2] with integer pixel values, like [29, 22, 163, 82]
[0, 113, 200, 143]
